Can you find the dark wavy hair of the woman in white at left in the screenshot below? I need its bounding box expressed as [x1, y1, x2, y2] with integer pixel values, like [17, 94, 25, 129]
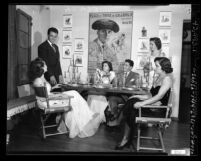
[29, 58, 44, 81]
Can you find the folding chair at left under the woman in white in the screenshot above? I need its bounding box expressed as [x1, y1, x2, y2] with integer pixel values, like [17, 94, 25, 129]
[34, 84, 73, 139]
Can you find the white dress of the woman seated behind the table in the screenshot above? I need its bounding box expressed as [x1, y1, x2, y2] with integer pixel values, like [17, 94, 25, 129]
[87, 71, 115, 123]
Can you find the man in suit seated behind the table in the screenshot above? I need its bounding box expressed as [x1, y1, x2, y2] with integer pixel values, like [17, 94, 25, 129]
[108, 59, 139, 124]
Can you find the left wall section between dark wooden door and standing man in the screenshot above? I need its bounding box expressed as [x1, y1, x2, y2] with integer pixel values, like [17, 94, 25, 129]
[16, 5, 50, 60]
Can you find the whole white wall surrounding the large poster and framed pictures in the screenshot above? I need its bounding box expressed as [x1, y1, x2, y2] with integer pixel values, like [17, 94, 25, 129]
[16, 4, 191, 117]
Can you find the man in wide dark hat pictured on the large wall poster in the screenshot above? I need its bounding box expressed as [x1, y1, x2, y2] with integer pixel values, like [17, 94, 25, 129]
[89, 19, 119, 71]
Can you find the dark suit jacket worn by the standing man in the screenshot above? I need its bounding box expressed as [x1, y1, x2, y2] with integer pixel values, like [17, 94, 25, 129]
[38, 40, 62, 83]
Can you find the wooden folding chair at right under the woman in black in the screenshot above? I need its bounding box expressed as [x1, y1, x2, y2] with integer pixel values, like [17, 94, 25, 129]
[136, 90, 172, 152]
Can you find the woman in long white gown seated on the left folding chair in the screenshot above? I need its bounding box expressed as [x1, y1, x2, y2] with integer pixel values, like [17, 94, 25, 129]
[29, 58, 100, 138]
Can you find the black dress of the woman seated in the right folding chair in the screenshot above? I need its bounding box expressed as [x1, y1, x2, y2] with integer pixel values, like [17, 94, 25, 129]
[123, 86, 171, 129]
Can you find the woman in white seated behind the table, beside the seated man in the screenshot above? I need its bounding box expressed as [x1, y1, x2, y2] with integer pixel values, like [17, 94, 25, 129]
[87, 61, 115, 122]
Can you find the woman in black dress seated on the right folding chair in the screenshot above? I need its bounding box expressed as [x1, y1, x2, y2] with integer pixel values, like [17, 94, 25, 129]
[115, 57, 173, 150]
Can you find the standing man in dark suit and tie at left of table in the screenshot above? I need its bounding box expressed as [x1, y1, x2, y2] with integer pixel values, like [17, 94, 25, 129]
[38, 27, 63, 86]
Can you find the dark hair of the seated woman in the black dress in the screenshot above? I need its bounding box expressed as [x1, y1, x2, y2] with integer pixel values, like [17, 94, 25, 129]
[154, 57, 173, 73]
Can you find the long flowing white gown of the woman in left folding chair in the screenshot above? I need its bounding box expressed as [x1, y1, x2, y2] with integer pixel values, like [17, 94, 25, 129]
[37, 83, 100, 138]
